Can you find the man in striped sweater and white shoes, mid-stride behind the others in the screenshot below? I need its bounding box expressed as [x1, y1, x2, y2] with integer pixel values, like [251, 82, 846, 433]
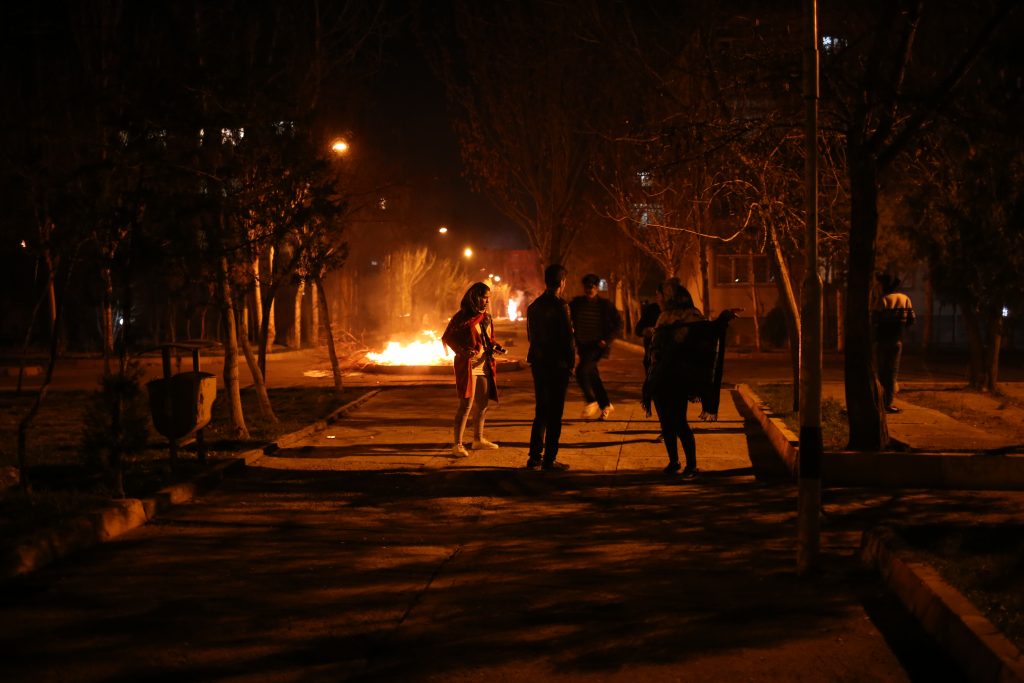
[569, 272, 622, 420]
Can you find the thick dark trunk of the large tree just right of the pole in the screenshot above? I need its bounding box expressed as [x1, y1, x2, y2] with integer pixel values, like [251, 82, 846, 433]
[844, 147, 889, 451]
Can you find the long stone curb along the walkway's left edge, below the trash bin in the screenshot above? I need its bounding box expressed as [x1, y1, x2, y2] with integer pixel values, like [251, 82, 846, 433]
[0, 389, 382, 581]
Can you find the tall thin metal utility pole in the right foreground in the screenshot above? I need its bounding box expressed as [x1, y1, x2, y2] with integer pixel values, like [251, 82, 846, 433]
[797, 0, 822, 574]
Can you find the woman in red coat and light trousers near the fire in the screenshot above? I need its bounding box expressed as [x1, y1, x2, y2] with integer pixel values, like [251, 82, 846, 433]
[441, 283, 505, 457]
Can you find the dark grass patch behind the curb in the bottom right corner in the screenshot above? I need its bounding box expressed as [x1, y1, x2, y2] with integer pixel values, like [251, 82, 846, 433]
[899, 524, 1024, 652]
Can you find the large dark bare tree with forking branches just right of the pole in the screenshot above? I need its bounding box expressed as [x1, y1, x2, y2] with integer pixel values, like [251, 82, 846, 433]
[822, 0, 1019, 451]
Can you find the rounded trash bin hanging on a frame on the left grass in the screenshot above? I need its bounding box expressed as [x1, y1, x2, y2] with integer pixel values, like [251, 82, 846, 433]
[145, 372, 217, 440]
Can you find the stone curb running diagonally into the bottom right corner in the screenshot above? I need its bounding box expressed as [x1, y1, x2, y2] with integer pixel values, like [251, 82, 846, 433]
[860, 527, 1024, 683]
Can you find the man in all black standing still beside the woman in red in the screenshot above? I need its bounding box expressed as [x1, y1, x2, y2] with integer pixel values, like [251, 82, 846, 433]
[526, 263, 575, 470]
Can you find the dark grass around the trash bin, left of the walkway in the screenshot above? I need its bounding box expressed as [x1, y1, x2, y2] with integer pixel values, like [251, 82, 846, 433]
[0, 387, 370, 539]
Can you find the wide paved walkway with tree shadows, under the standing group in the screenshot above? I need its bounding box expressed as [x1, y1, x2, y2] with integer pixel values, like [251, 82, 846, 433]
[0, 342, 1022, 683]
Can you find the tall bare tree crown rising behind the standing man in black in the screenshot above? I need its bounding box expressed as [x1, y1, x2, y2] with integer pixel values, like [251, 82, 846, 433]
[434, 0, 601, 263]
